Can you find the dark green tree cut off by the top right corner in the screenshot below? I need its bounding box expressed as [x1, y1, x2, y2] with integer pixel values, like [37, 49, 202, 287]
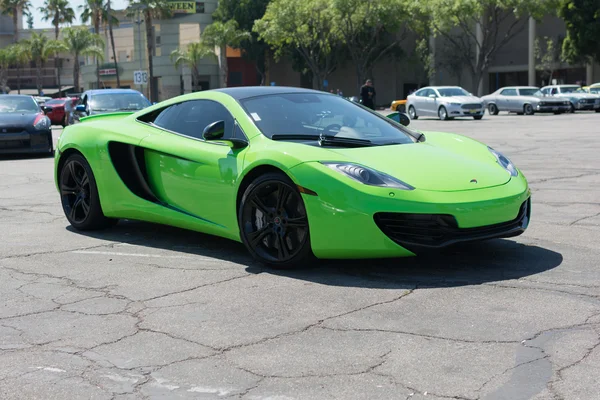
[558, 0, 600, 67]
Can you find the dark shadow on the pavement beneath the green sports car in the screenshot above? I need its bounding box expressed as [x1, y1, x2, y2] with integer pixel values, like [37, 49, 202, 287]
[67, 221, 563, 288]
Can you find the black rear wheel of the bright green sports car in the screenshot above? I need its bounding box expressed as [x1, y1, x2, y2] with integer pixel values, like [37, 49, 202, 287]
[58, 154, 118, 231]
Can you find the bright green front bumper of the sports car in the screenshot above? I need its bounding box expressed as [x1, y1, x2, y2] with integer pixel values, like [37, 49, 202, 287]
[290, 163, 530, 258]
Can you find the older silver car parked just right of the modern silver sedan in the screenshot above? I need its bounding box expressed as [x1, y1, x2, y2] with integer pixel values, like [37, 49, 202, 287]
[481, 86, 571, 115]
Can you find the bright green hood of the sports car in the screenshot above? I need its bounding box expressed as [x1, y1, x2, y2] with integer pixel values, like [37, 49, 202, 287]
[278, 132, 510, 192]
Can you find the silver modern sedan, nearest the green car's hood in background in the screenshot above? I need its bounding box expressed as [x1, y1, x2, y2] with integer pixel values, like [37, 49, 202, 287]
[406, 86, 484, 120]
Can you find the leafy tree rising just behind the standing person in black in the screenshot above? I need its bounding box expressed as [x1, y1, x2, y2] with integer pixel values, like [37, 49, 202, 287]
[331, 0, 410, 88]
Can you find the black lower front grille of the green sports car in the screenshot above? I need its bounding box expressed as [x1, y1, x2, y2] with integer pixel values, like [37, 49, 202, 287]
[374, 200, 531, 249]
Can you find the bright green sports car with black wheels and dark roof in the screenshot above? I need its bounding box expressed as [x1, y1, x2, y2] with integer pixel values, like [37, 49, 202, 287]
[55, 87, 531, 268]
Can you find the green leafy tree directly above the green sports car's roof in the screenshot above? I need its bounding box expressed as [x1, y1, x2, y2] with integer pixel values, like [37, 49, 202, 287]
[254, 0, 342, 89]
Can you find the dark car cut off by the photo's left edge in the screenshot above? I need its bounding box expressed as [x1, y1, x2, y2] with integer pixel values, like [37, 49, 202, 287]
[0, 95, 54, 154]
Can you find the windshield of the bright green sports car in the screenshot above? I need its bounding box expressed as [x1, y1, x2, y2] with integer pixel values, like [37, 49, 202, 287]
[241, 93, 413, 145]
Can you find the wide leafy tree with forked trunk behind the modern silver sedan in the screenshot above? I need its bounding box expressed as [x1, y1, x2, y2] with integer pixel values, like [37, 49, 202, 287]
[422, 0, 554, 95]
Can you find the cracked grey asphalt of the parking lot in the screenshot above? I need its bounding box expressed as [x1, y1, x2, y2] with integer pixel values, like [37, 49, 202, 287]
[0, 113, 600, 400]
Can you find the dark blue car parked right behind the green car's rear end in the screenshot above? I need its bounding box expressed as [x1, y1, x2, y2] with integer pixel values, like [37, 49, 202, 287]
[75, 89, 151, 120]
